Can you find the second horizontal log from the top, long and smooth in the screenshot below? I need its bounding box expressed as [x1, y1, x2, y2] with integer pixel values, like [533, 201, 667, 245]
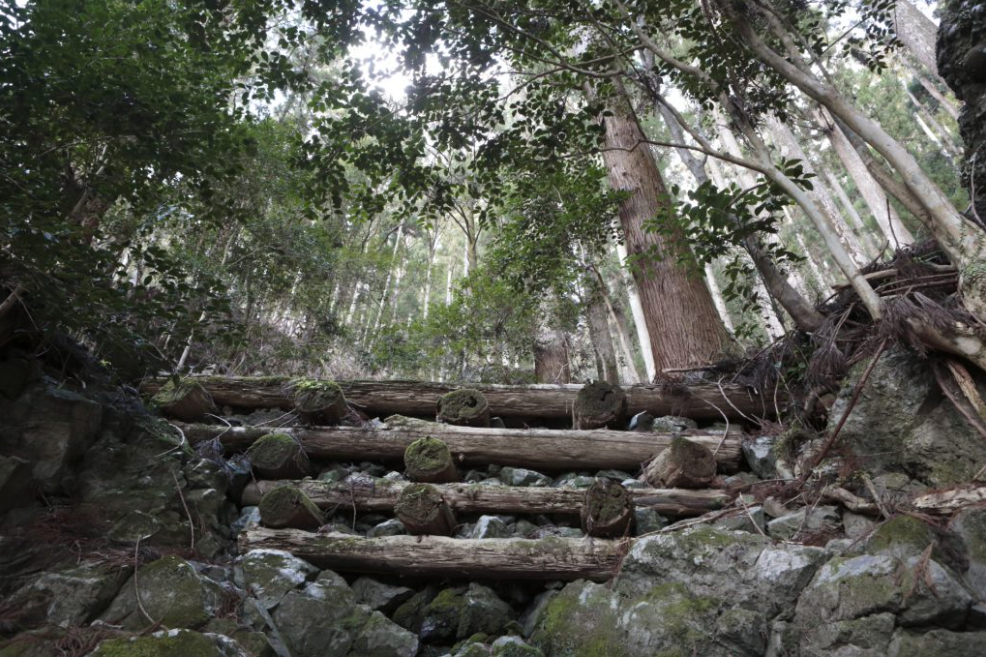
[176, 418, 741, 473]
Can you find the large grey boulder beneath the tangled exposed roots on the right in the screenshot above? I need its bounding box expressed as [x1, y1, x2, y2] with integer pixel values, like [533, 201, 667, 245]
[828, 348, 986, 487]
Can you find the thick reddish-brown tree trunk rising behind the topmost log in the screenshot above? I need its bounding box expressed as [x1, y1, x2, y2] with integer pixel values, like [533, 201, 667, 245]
[603, 98, 731, 373]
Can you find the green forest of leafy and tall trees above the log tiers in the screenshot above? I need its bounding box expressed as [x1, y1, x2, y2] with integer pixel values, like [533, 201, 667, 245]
[0, 0, 968, 383]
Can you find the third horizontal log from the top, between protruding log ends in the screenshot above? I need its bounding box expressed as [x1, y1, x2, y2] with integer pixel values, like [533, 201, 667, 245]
[241, 477, 730, 517]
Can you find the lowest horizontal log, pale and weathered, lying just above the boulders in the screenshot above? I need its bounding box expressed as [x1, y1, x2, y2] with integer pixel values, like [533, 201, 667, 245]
[239, 527, 626, 582]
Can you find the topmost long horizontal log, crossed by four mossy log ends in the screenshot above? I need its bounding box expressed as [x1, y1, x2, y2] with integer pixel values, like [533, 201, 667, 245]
[141, 376, 772, 420]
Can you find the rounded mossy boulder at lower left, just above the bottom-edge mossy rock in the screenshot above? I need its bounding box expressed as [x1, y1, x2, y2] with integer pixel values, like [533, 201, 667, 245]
[100, 555, 223, 631]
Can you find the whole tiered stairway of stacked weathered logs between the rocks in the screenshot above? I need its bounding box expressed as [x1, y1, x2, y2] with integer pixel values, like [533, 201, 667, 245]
[150, 377, 760, 581]
